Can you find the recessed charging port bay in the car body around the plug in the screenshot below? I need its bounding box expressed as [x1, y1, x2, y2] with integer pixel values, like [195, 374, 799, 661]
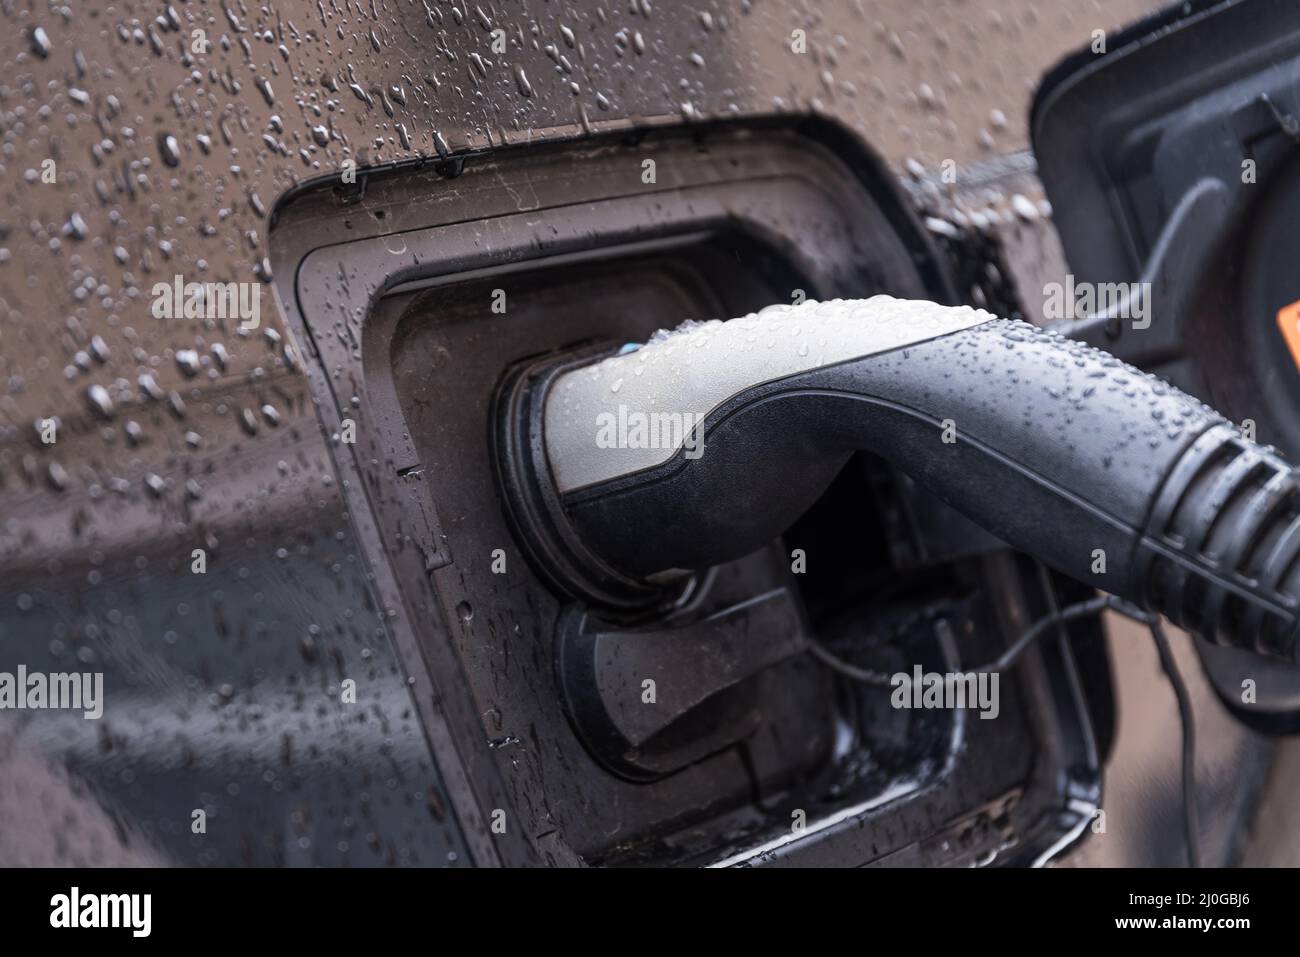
[272, 121, 1100, 865]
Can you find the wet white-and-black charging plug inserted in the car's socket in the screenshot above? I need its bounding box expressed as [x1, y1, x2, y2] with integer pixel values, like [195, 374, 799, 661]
[498, 296, 1300, 661]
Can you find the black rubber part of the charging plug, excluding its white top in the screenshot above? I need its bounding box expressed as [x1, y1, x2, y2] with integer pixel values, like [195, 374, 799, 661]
[548, 320, 1300, 661]
